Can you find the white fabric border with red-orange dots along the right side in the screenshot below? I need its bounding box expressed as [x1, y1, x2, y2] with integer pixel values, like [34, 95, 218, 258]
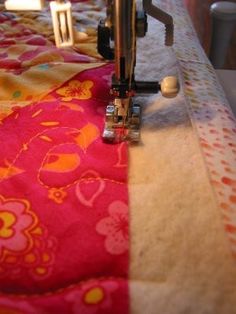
[160, 0, 236, 257]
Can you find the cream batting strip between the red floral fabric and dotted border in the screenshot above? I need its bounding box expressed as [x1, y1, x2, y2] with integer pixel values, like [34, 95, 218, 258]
[129, 1, 236, 314]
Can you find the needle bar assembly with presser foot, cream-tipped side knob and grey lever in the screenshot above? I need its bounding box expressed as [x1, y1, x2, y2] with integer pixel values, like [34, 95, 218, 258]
[98, 0, 179, 142]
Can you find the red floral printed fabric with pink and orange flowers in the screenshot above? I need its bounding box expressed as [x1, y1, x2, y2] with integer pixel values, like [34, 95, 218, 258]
[0, 4, 129, 314]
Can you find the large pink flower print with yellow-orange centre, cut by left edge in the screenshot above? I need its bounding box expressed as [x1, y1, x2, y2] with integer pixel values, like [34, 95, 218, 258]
[0, 196, 37, 261]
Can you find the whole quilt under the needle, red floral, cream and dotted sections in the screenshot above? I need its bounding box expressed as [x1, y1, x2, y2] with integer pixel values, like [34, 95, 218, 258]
[0, 0, 236, 314]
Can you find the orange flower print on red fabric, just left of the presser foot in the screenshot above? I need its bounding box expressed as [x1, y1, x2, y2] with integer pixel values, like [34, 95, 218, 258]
[57, 80, 94, 101]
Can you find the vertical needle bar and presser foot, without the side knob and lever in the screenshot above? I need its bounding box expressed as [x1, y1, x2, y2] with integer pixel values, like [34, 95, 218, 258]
[98, 0, 140, 142]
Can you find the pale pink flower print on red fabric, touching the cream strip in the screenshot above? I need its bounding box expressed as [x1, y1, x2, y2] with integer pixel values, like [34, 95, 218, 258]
[96, 201, 129, 255]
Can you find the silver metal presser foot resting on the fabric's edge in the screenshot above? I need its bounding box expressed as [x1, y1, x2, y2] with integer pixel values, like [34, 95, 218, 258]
[102, 99, 141, 143]
